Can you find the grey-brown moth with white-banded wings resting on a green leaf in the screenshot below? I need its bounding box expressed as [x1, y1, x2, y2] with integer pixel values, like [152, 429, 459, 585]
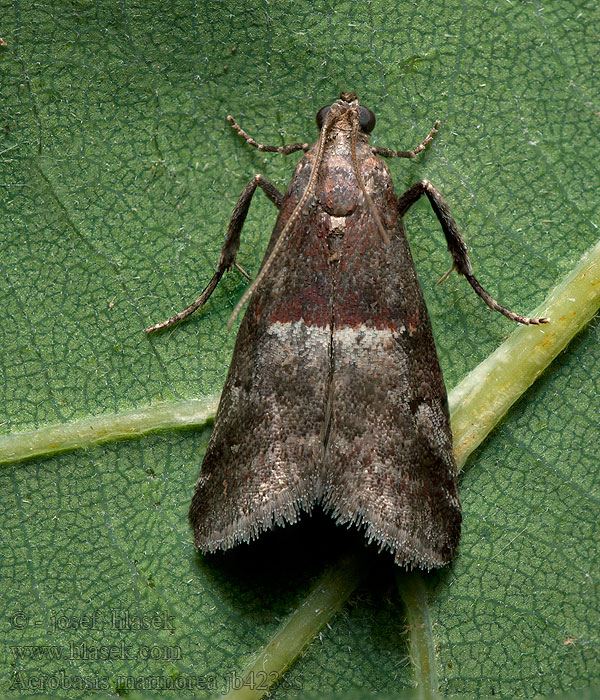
[147, 92, 548, 569]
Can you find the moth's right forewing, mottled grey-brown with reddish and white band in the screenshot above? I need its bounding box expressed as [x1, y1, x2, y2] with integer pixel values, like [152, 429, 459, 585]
[323, 201, 461, 568]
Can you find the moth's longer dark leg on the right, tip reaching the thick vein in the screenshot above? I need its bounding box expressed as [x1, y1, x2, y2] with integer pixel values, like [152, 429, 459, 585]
[398, 180, 550, 326]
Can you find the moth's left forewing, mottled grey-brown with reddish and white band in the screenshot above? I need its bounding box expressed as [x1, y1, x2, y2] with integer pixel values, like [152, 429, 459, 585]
[190, 152, 332, 552]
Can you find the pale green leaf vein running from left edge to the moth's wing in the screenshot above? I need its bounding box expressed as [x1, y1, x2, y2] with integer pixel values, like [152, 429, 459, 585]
[0, 397, 219, 464]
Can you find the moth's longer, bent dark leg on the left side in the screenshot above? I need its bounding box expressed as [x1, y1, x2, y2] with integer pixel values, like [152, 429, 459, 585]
[146, 175, 283, 333]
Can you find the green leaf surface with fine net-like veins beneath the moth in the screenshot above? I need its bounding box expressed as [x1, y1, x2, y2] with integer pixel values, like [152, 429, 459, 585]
[0, 0, 600, 698]
